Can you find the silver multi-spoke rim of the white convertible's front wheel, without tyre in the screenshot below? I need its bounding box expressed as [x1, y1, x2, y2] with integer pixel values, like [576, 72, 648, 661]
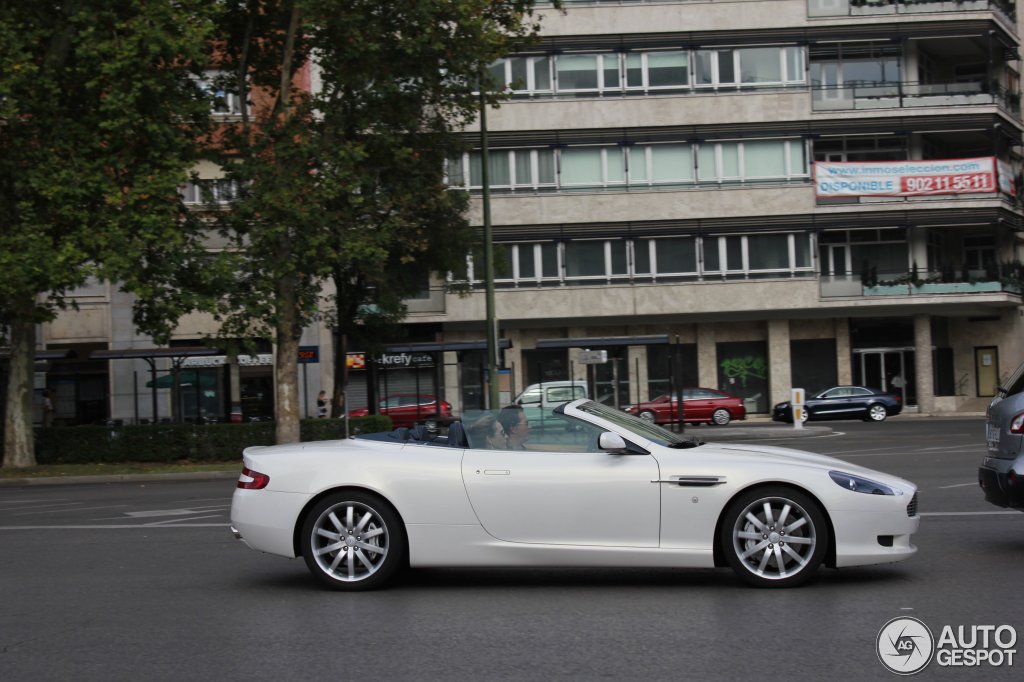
[732, 497, 817, 581]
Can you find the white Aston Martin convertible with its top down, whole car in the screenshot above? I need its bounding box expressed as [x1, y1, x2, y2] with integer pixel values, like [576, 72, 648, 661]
[231, 399, 921, 590]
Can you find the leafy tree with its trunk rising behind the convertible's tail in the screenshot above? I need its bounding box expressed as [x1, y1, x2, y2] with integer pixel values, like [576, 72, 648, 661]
[214, 0, 552, 442]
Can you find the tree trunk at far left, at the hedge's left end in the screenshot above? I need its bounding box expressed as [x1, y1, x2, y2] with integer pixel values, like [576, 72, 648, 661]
[3, 315, 36, 469]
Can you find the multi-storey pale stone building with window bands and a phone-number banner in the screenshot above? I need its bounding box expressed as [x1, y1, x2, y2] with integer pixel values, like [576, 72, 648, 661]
[9, 0, 1024, 419]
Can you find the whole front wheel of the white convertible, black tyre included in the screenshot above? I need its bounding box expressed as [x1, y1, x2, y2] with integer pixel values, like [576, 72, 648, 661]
[719, 486, 828, 587]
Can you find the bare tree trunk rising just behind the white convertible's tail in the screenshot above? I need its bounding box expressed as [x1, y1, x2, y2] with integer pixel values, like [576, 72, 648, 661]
[274, 276, 302, 444]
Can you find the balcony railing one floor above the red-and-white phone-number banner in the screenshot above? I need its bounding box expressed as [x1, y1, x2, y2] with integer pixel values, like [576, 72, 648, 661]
[811, 81, 1020, 116]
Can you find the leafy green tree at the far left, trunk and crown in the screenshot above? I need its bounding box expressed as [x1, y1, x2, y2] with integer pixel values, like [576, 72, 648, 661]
[0, 0, 213, 467]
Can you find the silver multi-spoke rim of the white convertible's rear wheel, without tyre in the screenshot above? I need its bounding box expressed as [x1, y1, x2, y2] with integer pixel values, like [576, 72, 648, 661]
[309, 502, 390, 583]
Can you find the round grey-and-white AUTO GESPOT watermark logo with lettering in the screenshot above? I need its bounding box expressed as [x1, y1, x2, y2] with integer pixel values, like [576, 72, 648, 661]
[876, 617, 1017, 675]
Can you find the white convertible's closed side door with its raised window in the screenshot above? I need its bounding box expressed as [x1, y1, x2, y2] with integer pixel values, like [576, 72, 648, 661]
[462, 411, 660, 547]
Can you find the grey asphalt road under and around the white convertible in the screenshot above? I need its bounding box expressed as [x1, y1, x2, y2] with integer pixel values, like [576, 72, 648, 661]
[0, 418, 1024, 682]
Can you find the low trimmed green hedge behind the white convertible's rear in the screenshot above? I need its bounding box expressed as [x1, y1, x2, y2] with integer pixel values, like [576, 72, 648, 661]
[29, 415, 391, 464]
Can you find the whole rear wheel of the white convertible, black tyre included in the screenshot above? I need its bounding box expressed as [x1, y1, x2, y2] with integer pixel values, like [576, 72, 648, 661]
[300, 491, 406, 590]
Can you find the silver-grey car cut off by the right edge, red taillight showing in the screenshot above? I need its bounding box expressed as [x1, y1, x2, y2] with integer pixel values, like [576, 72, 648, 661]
[978, 365, 1024, 509]
